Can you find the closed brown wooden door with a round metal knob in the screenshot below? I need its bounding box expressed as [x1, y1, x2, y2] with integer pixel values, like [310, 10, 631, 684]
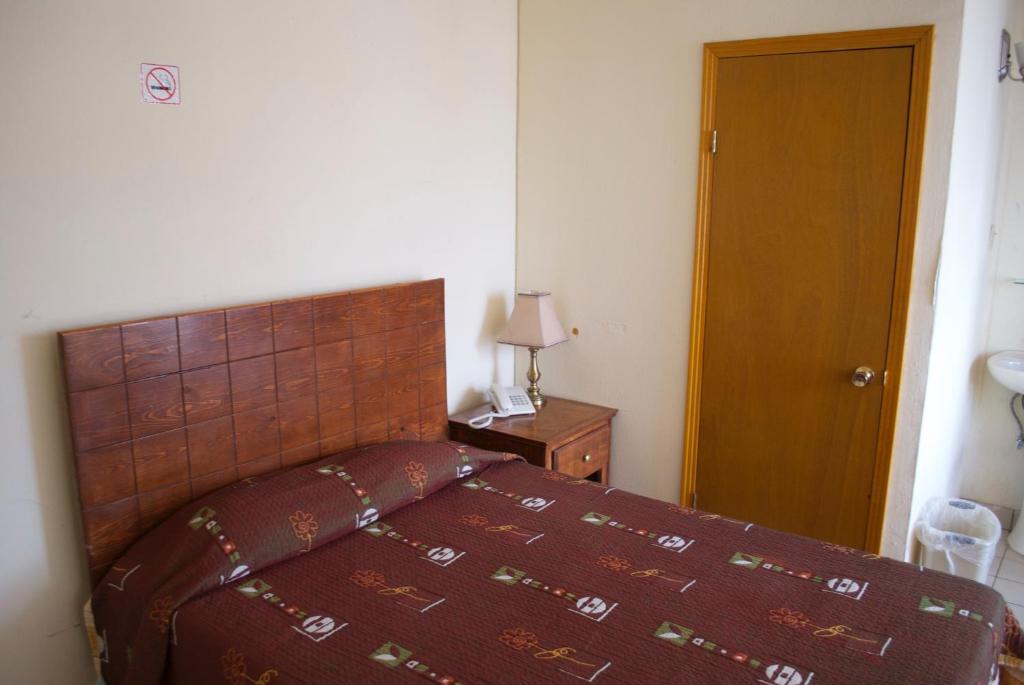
[691, 28, 933, 548]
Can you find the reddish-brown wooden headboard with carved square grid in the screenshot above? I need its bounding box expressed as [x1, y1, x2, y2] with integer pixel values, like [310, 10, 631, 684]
[58, 279, 447, 583]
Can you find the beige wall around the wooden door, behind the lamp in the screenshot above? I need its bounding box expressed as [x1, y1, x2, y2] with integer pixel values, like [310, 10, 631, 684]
[517, 0, 966, 557]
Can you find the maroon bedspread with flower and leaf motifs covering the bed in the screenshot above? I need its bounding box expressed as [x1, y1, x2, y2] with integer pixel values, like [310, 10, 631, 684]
[93, 443, 1004, 685]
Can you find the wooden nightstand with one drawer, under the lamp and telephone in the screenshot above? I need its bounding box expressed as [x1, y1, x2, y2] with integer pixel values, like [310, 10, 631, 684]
[449, 397, 618, 484]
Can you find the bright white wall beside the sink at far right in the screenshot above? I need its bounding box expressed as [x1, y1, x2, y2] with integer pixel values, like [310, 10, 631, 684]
[908, 0, 1024, 549]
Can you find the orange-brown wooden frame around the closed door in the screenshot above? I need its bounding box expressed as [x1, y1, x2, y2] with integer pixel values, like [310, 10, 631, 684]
[680, 26, 933, 553]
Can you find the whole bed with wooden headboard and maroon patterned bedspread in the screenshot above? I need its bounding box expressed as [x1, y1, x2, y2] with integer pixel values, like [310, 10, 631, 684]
[60, 281, 1007, 685]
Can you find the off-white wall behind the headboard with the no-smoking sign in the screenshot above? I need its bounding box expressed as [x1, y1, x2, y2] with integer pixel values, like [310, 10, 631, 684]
[0, 0, 516, 684]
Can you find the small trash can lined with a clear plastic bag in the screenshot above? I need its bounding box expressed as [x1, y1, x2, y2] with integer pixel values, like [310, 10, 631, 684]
[916, 498, 1002, 583]
